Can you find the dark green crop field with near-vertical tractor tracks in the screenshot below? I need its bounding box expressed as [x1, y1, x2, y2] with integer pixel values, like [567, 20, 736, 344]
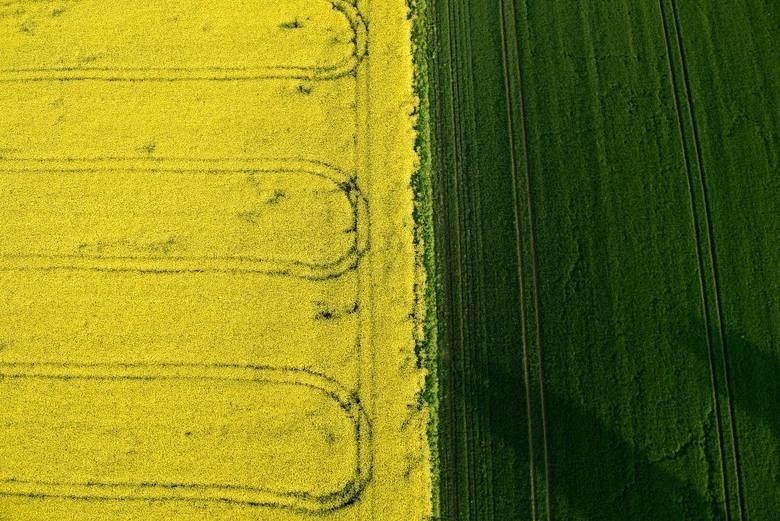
[418, 0, 780, 521]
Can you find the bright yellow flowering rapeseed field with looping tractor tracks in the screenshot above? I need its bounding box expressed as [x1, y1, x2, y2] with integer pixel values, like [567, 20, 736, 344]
[0, 0, 431, 521]
